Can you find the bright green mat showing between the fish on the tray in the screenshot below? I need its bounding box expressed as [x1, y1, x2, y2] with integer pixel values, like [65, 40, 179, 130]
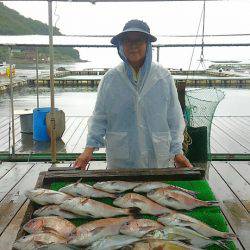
[50, 180, 236, 250]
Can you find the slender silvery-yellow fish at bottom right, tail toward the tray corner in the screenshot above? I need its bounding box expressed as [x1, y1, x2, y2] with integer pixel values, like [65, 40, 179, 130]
[144, 226, 227, 248]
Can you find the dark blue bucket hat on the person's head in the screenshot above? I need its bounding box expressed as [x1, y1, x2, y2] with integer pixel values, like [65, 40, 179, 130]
[111, 19, 157, 46]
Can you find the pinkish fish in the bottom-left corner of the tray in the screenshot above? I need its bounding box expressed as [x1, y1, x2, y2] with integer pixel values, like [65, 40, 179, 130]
[13, 233, 67, 250]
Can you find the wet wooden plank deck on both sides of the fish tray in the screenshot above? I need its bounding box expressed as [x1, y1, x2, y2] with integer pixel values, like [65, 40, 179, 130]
[0, 161, 250, 250]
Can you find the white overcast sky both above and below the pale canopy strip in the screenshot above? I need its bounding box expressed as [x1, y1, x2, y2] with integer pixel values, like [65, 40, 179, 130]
[3, 0, 250, 67]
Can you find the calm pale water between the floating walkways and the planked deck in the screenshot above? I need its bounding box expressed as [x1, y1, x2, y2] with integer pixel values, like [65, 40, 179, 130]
[0, 87, 250, 117]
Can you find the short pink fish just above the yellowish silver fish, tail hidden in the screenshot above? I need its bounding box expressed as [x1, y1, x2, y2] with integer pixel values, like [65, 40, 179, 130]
[120, 219, 164, 238]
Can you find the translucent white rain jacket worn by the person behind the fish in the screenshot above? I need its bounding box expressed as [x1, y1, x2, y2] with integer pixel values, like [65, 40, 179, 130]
[86, 45, 185, 168]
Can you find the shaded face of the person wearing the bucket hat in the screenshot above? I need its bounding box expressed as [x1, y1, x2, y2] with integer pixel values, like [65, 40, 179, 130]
[122, 32, 147, 66]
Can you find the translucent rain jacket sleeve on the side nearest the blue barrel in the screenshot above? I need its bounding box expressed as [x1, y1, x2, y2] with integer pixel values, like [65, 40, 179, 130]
[86, 76, 107, 149]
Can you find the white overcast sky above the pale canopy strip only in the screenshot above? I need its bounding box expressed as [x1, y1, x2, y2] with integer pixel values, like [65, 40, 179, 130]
[3, 0, 250, 35]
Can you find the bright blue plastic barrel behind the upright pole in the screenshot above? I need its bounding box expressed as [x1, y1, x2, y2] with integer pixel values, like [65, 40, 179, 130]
[33, 108, 58, 141]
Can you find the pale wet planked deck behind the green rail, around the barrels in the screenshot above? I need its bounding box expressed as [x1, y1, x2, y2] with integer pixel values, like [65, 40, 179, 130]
[0, 116, 250, 154]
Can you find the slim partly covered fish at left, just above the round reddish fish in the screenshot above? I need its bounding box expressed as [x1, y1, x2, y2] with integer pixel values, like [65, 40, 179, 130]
[33, 205, 82, 219]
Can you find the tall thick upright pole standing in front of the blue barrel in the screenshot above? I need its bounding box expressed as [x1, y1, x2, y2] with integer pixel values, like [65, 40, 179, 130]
[48, 0, 56, 163]
